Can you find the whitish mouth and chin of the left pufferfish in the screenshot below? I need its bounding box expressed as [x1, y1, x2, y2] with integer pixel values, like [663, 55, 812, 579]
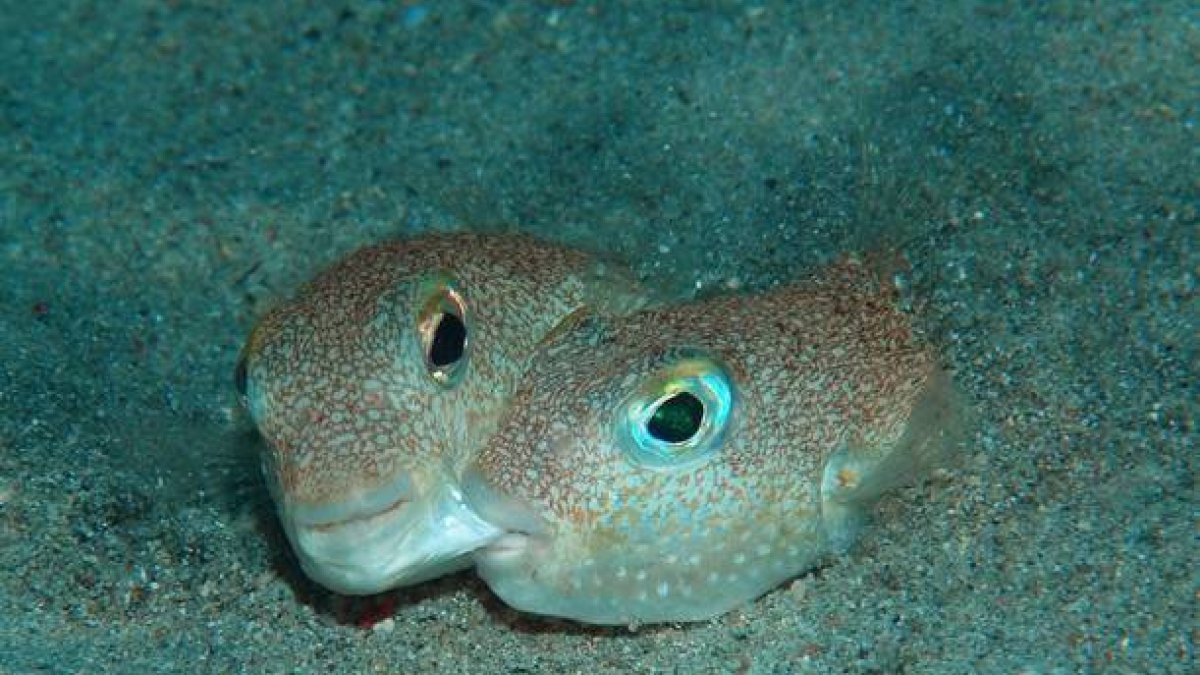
[280, 476, 503, 596]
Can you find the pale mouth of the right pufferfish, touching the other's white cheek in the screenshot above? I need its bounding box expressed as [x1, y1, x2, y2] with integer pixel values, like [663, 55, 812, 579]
[462, 467, 551, 563]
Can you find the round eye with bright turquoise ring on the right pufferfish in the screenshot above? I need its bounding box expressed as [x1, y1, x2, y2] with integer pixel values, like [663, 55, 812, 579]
[616, 354, 734, 470]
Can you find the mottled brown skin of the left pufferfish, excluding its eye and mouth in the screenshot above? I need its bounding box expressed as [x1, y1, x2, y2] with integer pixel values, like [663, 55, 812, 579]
[236, 234, 637, 592]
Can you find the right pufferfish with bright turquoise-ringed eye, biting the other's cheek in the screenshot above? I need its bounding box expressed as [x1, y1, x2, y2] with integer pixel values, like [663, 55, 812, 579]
[463, 259, 960, 625]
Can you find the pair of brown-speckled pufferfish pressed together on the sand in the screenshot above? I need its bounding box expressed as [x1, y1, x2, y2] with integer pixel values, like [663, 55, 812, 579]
[235, 234, 964, 625]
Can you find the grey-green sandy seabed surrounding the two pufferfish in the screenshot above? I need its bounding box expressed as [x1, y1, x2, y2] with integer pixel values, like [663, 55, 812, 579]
[0, 0, 1200, 675]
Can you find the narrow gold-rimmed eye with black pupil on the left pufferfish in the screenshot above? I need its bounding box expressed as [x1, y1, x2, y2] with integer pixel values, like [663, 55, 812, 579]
[416, 274, 470, 387]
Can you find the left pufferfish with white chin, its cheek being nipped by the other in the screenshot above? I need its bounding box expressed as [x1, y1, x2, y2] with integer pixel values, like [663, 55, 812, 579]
[235, 234, 642, 595]
